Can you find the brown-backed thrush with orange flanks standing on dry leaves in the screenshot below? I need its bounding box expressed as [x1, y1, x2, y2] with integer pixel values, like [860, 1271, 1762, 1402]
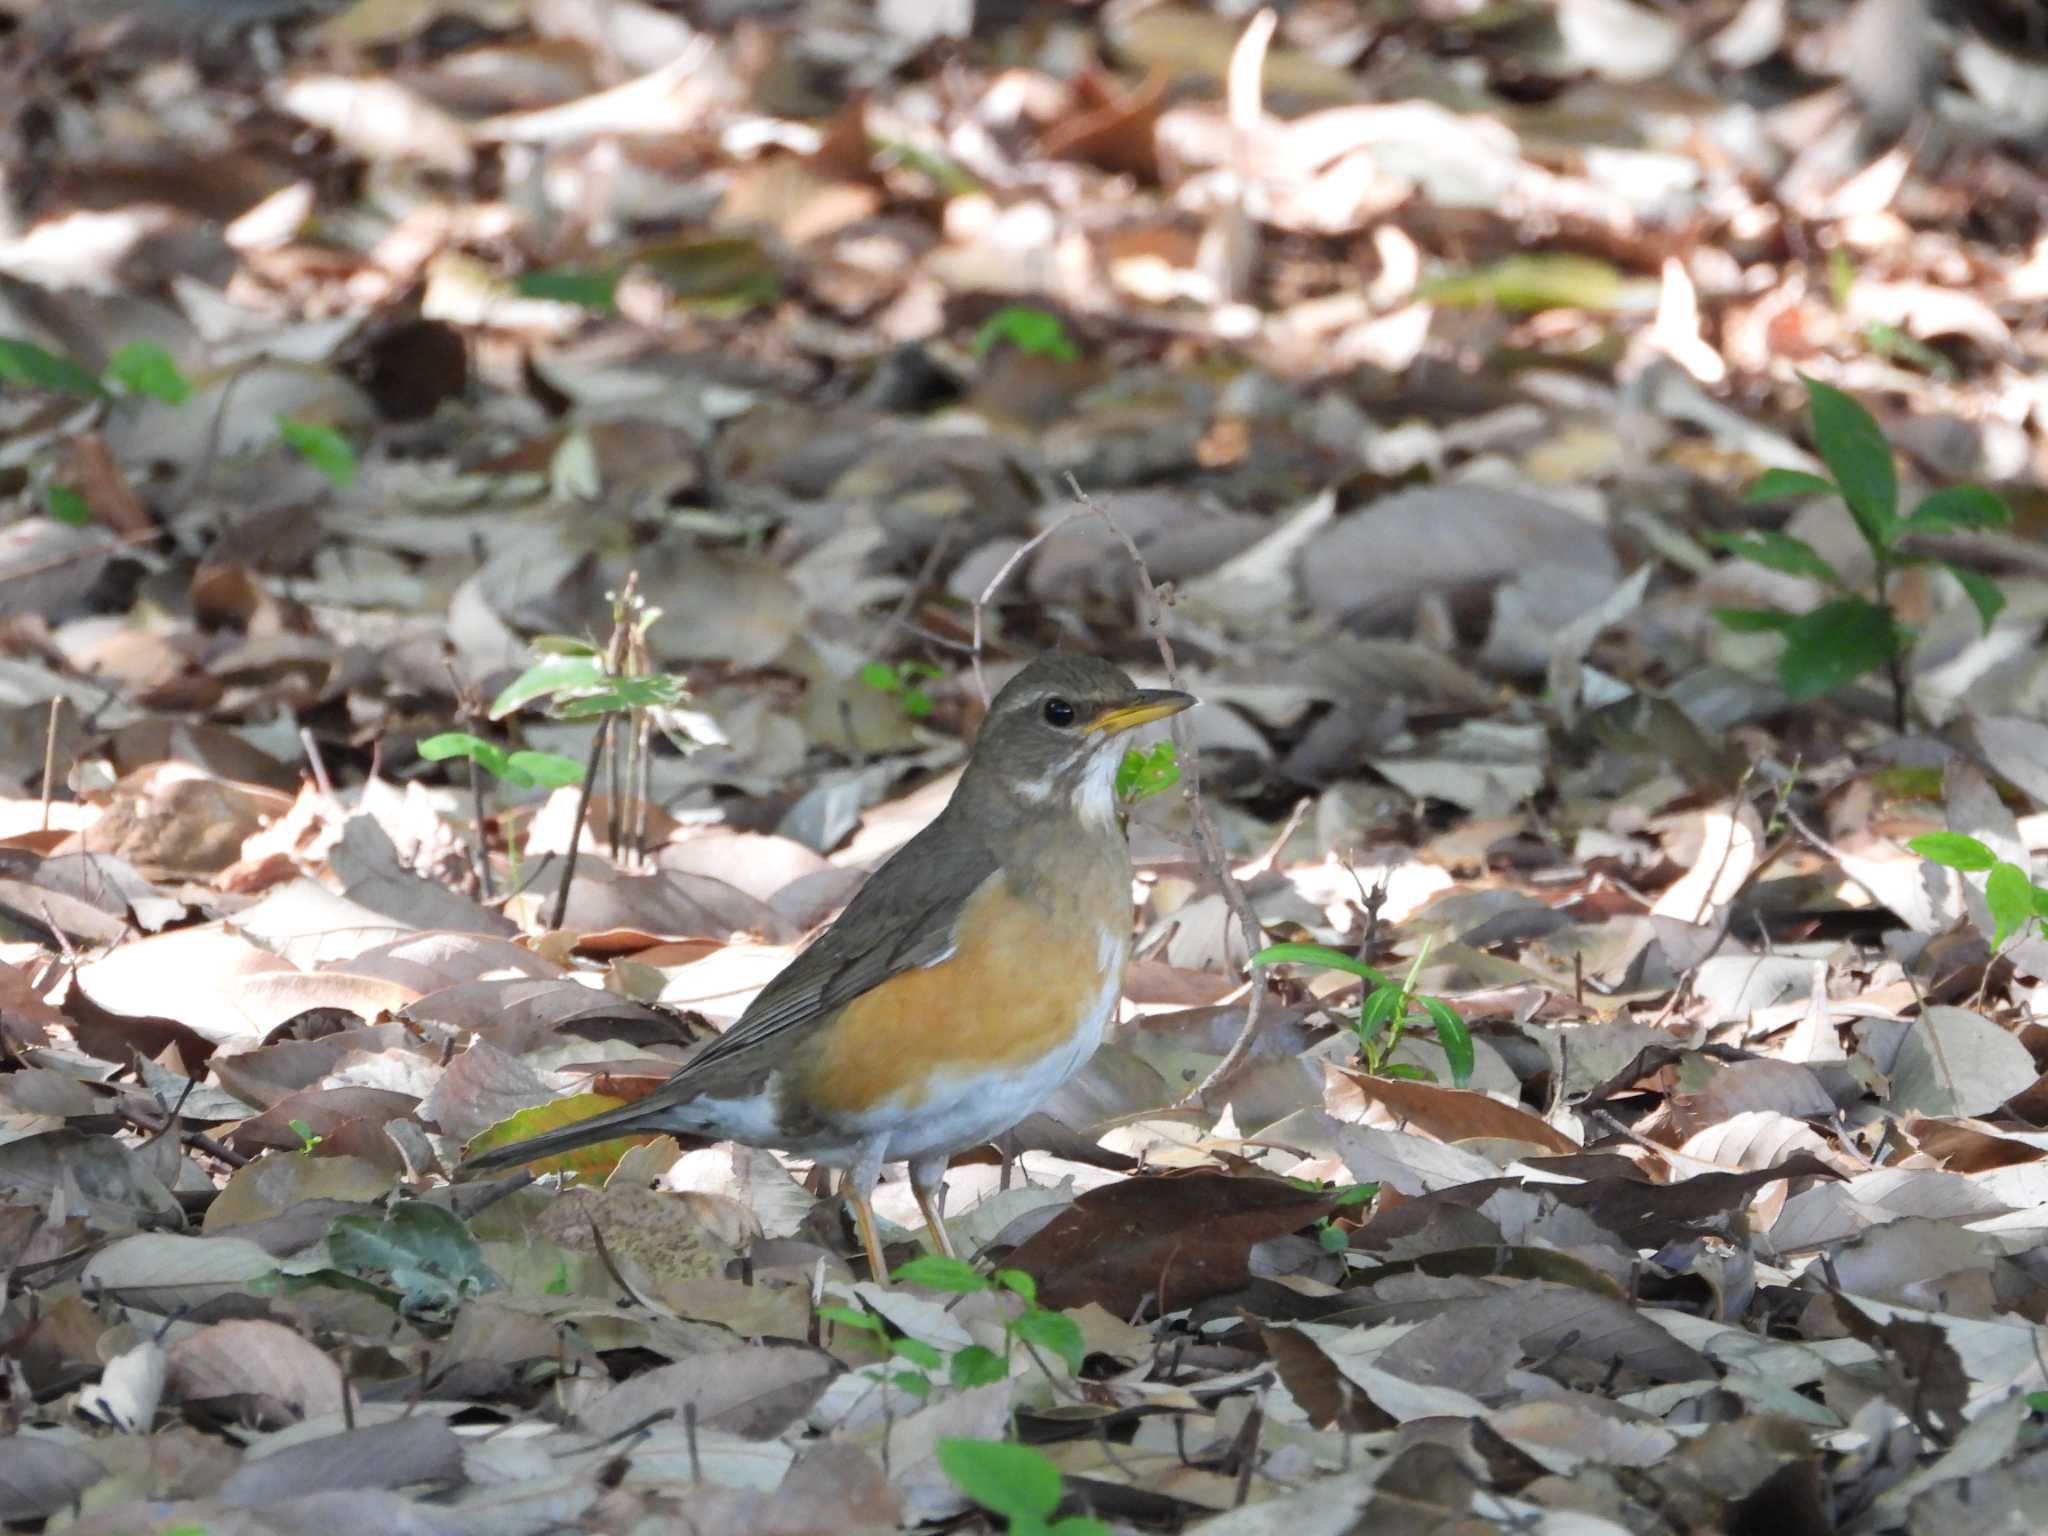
[455, 651, 1196, 1280]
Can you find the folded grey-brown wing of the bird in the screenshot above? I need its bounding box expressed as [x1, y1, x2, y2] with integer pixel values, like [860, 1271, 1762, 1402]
[662, 829, 997, 1096]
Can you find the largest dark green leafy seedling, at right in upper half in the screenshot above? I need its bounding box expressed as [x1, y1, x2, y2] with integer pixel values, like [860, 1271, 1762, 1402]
[1714, 375, 2013, 729]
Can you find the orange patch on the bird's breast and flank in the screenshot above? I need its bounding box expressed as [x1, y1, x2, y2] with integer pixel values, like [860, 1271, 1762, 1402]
[793, 874, 1130, 1120]
